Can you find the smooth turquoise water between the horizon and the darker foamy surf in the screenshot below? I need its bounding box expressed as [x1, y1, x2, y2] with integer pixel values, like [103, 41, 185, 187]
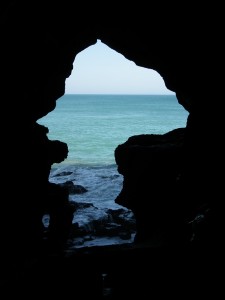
[38, 94, 188, 165]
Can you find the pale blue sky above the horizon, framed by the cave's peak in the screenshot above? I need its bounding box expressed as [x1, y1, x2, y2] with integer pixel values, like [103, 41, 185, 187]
[65, 40, 175, 95]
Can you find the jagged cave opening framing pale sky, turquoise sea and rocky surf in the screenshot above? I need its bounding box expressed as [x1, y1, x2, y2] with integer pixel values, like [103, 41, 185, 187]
[38, 41, 187, 247]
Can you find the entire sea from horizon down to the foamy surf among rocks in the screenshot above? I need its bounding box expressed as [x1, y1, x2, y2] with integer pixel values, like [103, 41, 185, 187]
[38, 94, 188, 247]
